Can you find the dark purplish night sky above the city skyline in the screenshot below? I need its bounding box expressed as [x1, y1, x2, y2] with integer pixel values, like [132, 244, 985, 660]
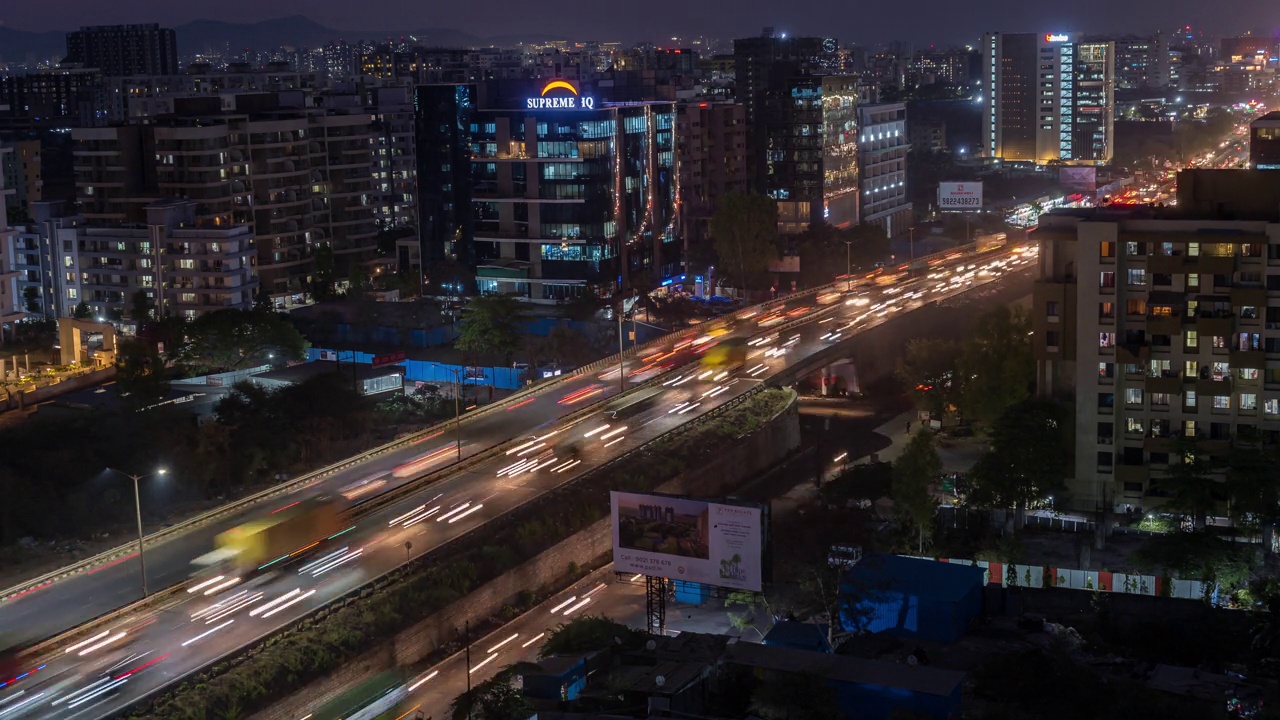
[0, 0, 1280, 45]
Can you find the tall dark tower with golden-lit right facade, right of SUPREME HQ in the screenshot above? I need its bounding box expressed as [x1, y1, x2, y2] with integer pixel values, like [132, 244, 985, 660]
[733, 35, 859, 233]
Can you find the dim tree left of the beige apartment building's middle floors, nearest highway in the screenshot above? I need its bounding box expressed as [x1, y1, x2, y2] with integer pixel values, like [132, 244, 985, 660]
[960, 305, 1036, 423]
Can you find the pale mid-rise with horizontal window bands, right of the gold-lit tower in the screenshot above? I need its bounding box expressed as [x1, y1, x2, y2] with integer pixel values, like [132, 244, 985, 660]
[858, 102, 911, 237]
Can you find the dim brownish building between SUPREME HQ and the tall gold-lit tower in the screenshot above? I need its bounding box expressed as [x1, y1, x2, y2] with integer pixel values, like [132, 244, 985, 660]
[676, 102, 750, 257]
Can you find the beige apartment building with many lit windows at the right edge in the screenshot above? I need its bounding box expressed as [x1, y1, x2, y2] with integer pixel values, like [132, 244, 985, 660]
[1032, 170, 1280, 511]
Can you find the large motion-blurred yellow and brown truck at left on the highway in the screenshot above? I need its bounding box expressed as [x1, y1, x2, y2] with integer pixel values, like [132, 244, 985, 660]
[192, 496, 348, 579]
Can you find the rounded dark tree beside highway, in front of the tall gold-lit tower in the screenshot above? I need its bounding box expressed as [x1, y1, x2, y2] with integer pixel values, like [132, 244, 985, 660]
[710, 192, 778, 292]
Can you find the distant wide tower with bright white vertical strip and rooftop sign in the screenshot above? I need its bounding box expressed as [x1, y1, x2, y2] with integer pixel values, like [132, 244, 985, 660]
[980, 33, 1115, 165]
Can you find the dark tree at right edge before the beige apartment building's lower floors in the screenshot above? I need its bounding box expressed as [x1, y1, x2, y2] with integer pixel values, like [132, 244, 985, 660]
[1226, 428, 1280, 555]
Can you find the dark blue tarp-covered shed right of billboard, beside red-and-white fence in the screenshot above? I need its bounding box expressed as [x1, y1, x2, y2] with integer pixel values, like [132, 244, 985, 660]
[840, 555, 986, 643]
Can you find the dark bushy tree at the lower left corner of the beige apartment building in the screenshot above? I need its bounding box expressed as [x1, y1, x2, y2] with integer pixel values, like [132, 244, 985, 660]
[970, 397, 1071, 530]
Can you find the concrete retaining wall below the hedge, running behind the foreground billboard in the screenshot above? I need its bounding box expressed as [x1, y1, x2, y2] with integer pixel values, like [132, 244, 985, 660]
[247, 389, 800, 720]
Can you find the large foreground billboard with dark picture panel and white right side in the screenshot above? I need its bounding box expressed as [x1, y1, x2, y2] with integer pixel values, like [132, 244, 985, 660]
[609, 492, 764, 592]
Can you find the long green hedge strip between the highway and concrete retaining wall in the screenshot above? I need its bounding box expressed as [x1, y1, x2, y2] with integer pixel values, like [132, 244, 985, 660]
[133, 388, 792, 720]
